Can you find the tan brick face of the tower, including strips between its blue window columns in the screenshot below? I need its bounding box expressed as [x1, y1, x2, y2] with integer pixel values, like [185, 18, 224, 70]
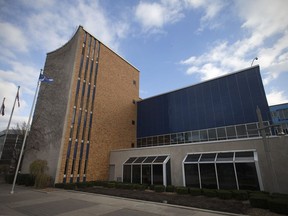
[58, 28, 139, 182]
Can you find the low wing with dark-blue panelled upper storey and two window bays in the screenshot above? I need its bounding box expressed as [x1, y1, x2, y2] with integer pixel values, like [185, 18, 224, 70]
[110, 66, 288, 193]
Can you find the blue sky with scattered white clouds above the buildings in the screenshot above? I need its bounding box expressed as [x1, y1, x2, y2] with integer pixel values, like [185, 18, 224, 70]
[0, 0, 288, 131]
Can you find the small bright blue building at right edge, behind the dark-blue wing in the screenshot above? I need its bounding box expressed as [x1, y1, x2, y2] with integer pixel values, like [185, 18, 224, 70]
[270, 103, 288, 134]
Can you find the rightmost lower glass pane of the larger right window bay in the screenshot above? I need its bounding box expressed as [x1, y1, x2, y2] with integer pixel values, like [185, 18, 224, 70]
[235, 163, 260, 190]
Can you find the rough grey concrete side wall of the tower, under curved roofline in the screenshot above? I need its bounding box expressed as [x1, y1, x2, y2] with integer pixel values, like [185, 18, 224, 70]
[22, 26, 79, 178]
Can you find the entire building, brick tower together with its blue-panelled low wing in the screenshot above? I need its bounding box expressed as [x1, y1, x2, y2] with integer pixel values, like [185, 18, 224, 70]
[23, 26, 288, 193]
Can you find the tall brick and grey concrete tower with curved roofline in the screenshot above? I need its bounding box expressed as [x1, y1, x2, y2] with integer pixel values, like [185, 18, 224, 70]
[23, 26, 139, 182]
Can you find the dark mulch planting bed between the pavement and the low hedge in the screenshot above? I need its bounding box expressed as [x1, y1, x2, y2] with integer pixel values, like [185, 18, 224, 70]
[78, 187, 251, 214]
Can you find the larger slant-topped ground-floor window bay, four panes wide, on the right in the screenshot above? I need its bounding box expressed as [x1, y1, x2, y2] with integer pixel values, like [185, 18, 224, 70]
[183, 151, 260, 190]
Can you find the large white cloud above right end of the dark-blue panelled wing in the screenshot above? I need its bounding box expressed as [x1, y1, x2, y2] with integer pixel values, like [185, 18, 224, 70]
[180, 0, 288, 92]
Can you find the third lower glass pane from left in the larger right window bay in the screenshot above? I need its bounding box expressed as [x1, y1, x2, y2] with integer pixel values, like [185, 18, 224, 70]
[216, 163, 237, 190]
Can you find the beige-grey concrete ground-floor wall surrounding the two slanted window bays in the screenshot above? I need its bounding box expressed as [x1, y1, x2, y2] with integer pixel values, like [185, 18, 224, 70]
[110, 136, 288, 193]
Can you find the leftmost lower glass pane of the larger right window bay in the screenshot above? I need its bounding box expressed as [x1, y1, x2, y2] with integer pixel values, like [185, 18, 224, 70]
[184, 164, 200, 188]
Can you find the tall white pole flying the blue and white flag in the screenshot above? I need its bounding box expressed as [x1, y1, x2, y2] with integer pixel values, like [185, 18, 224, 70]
[10, 69, 42, 194]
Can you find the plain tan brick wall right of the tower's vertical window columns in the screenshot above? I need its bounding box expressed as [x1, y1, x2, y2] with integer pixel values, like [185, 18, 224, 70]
[87, 44, 139, 180]
